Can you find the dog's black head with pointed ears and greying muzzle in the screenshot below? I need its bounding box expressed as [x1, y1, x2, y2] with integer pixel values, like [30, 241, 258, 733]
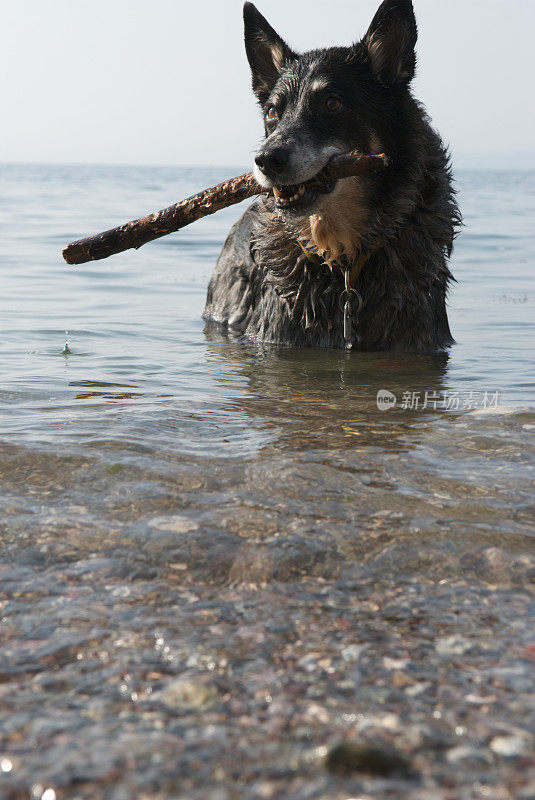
[244, 0, 417, 238]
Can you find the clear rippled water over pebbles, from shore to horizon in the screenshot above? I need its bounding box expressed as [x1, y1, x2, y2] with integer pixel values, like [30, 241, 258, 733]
[0, 165, 535, 800]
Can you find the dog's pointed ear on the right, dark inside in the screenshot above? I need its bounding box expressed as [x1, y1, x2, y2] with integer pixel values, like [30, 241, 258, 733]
[363, 0, 418, 86]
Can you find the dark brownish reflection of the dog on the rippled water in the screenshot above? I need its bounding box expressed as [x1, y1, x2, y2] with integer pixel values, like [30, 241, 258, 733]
[205, 326, 451, 452]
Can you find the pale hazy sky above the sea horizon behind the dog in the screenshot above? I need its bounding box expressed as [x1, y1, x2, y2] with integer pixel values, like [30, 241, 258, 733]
[0, 0, 535, 166]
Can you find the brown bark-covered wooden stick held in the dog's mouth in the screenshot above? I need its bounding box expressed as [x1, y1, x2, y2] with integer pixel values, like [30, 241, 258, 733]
[63, 150, 388, 264]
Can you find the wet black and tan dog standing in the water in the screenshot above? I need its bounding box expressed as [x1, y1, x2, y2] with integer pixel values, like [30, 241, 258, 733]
[204, 0, 461, 353]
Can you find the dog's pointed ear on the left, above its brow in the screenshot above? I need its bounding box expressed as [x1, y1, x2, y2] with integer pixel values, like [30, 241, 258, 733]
[243, 3, 297, 104]
